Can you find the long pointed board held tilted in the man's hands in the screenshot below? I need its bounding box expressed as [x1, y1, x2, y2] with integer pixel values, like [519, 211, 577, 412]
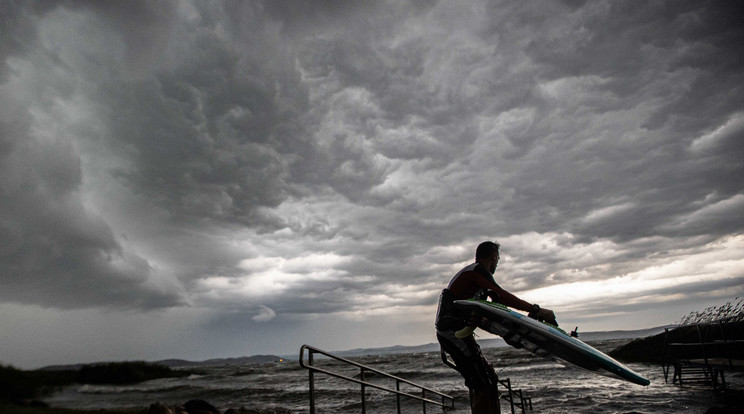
[454, 299, 651, 385]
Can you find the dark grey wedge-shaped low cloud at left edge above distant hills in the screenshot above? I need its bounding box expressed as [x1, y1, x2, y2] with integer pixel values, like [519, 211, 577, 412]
[0, 79, 179, 307]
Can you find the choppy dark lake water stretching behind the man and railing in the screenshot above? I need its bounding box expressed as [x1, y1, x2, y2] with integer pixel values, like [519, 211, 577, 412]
[45, 340, 744, 414]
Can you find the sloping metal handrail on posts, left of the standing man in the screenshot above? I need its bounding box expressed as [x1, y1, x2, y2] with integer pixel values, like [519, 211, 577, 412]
[300, 345, 455, 414]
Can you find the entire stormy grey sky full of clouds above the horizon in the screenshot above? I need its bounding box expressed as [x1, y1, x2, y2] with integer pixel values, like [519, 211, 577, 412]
[0, 0, 744, 368]
